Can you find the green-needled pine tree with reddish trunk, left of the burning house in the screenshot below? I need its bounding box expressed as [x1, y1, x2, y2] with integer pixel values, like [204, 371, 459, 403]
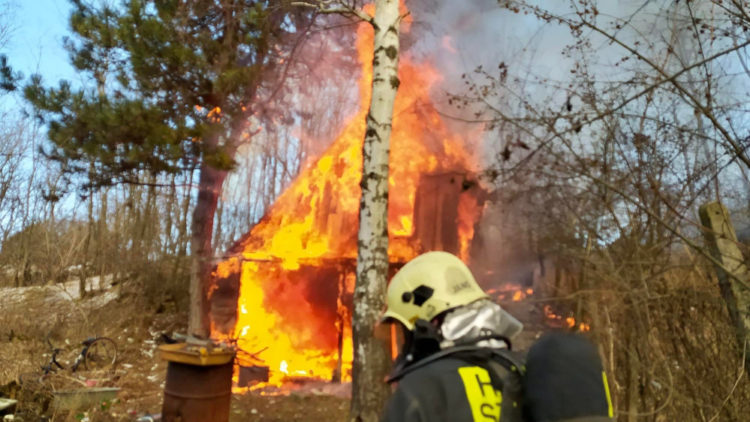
[24, 0, 306, 336]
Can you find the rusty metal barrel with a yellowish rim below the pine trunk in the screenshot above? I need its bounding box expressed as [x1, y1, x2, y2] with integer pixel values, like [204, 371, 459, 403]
[160, 343, 234, 422]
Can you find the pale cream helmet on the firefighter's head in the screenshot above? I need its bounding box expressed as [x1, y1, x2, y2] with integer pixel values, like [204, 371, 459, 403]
[383, 251, 488, 330]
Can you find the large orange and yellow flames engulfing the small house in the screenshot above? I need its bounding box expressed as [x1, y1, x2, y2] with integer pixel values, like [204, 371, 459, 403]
[214, 4, 481, 385]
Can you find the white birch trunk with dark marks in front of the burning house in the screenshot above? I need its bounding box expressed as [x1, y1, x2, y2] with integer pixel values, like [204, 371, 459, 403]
[349, 0, 400, 422]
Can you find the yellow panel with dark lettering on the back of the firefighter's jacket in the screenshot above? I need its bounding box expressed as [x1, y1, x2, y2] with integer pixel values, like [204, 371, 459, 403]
[458, 366, 503, 422]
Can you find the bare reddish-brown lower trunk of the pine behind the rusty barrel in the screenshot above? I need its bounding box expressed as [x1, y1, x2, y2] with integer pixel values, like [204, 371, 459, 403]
[188, 162, 227, 337]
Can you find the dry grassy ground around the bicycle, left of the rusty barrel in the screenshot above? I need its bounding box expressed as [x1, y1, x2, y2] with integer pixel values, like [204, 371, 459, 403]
[0, 276, 185, 421]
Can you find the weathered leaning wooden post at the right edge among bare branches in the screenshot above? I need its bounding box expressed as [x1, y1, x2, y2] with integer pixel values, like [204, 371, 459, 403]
[699, 202, 750, 374]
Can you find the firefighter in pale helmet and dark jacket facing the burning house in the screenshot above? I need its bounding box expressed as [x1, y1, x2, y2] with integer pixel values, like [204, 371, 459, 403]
[383, 252, 523, 422]
